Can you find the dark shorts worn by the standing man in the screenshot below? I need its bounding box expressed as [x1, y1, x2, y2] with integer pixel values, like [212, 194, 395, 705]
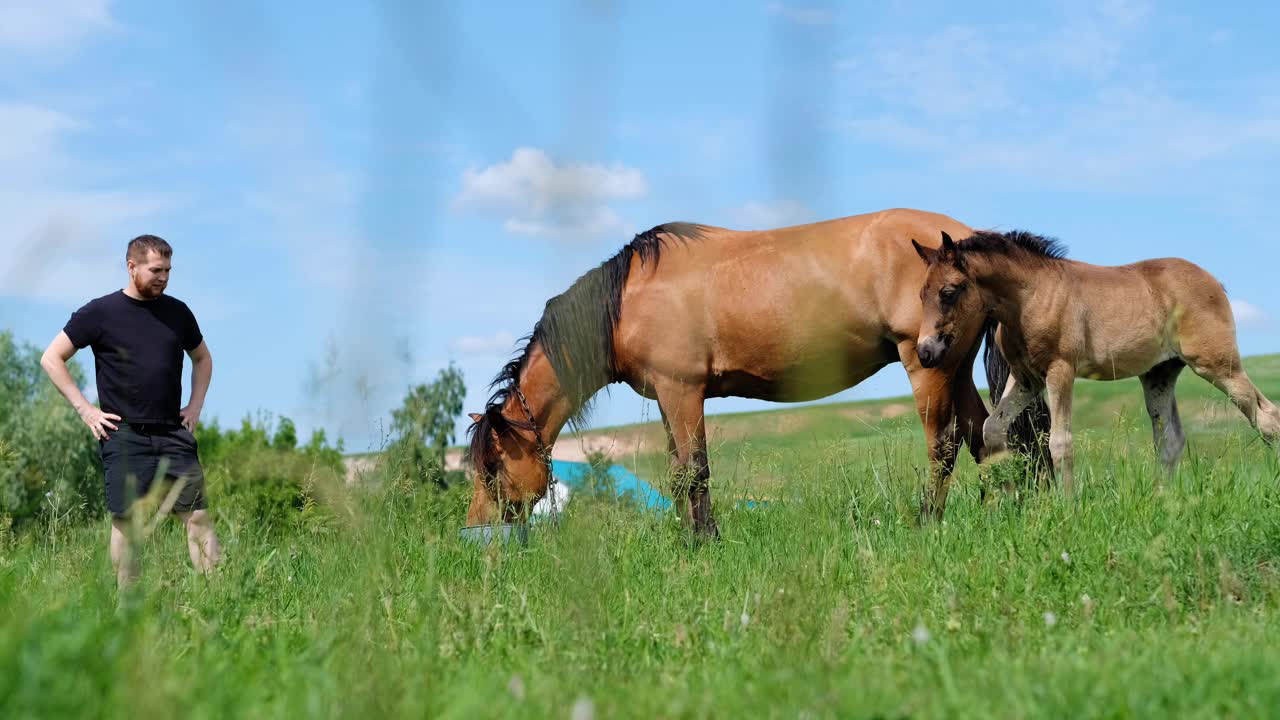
[99, 423, 209, 518]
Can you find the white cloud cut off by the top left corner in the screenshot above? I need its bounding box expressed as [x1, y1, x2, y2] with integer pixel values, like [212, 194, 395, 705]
[0, 0, 115, 55]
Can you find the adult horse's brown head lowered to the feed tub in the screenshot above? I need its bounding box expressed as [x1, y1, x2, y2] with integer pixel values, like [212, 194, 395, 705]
[467, 402, 550, 525]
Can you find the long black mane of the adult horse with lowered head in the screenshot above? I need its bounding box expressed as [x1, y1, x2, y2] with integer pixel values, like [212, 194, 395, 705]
[467, 223, 705, 477]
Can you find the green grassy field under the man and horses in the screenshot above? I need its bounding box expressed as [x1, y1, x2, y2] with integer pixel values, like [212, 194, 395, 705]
[0, 356, 1280, 719]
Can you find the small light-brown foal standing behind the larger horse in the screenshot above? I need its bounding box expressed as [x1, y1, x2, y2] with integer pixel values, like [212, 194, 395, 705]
[913, 231, 1280, 493]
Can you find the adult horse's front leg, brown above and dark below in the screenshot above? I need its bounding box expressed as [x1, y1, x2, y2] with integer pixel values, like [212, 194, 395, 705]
[654, 383, 719, 538]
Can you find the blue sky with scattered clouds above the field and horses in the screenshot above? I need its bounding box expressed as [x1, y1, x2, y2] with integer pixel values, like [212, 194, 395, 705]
[0, 0, 1280, 450]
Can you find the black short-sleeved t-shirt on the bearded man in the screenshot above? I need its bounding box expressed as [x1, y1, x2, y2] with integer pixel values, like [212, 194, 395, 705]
[63, 291, 204, 423]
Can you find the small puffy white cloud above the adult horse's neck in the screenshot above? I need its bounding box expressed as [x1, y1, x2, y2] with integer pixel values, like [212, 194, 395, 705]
[454, 147, 649, 237]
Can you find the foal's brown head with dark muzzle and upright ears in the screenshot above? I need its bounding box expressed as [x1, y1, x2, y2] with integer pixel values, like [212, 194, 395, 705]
[911, 232, 987, 368]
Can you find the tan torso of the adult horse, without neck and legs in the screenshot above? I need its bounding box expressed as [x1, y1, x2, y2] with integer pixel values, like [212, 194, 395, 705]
[618, 209, 968, 400]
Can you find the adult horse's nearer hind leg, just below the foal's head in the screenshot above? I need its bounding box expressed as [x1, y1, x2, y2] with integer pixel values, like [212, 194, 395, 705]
[899, 341, 960, 524]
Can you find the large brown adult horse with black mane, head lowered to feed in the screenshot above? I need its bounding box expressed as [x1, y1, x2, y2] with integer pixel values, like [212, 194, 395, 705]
[467, 210, 1049, 536]
